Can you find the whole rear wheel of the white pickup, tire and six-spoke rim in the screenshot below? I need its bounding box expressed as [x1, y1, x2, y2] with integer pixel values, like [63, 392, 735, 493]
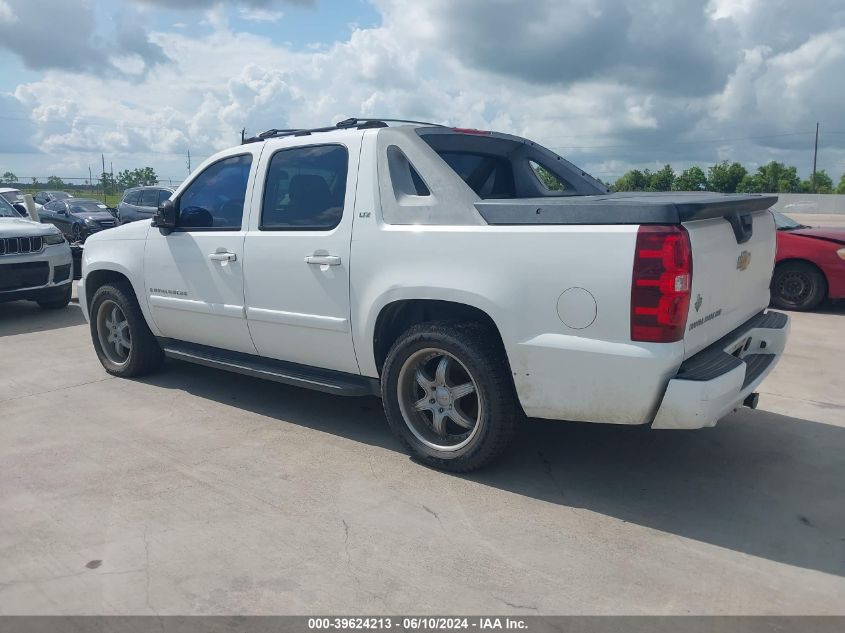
[382, 322, 521, 472]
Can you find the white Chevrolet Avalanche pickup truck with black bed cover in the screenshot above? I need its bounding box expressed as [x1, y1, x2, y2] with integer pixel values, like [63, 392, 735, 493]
[79, 119, 789, 471]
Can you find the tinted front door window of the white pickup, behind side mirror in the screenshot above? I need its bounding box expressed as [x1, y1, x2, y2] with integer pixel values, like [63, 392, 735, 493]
[177, 154, 252, 231]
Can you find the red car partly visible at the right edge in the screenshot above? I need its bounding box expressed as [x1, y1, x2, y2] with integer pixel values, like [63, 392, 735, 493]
[771, 211, 845, 310]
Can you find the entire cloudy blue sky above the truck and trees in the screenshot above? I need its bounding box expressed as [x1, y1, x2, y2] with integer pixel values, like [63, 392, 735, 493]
[0, 0, 845, 185]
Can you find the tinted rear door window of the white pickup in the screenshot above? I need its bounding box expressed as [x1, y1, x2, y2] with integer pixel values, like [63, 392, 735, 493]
[260, 145, 349, 231]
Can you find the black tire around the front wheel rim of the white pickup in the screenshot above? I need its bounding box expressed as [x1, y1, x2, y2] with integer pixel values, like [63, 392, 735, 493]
[90, 281, 164, 378]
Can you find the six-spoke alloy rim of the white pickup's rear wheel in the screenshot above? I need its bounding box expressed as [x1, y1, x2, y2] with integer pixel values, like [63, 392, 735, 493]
[398, 348, 483, 452]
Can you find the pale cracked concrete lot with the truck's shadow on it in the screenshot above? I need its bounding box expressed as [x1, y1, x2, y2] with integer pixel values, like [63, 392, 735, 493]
[0, 284, 845, 614]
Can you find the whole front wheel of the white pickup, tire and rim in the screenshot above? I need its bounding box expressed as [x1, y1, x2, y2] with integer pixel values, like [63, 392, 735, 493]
[91, 282, 164, 378]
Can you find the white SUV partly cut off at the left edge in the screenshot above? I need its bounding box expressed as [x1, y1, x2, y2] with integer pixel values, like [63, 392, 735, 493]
[0, 195, 73, 309]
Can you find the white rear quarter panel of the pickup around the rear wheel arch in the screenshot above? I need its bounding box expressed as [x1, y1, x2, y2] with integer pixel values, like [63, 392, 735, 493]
[350, 127, 683, 424]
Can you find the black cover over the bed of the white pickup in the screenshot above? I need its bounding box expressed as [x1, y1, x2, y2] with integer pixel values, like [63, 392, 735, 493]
[475, 191, 778, 225]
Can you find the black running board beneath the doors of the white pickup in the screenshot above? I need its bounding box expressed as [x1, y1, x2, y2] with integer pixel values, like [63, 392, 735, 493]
[158, 338, 380, 396]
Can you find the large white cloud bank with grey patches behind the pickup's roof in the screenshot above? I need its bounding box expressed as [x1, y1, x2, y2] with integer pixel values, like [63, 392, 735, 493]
[0, 0, 845, 178]
